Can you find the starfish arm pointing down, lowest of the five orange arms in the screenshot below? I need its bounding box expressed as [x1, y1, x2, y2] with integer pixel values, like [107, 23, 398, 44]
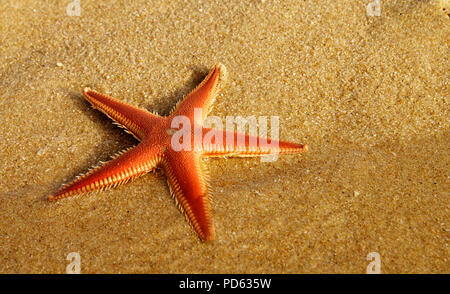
[162, 151, 214, 241]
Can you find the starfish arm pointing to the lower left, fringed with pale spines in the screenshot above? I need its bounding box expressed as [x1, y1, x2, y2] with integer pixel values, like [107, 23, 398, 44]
[48, 144, 161, 200]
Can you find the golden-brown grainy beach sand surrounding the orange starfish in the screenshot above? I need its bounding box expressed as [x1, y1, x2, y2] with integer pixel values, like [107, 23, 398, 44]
[0, 0, 450, 273]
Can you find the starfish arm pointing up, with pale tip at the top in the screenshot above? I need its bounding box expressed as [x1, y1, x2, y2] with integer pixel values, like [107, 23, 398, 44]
[171, 62, 227, 124]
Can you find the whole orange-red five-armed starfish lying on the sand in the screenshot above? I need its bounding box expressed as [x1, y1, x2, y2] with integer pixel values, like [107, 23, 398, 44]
[48, 63, 307, 241]
